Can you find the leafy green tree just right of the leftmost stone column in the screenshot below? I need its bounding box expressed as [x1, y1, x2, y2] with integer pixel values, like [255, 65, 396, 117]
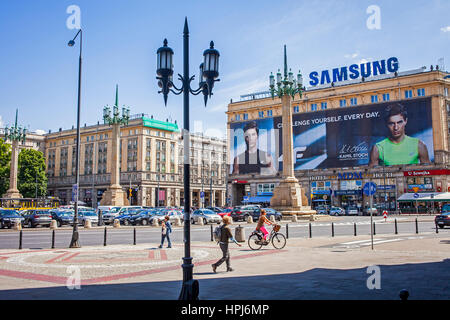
[17, 149, 48, 198]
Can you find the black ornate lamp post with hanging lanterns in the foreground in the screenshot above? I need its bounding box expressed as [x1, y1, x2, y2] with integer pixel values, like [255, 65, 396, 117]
[156, 18, 220, 300]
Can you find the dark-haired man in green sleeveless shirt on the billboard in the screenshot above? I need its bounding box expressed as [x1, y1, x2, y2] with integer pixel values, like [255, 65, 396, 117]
[369, 103, 430, 167]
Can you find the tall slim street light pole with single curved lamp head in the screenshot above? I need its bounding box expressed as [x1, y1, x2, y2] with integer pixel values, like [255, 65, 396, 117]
[68, 29, 83, 248]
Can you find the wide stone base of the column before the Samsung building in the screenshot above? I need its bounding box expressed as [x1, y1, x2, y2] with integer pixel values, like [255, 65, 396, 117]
[270, 177, 316, 216]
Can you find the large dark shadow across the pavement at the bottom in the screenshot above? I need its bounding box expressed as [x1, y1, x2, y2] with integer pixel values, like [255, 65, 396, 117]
[0, 259, 450, 300]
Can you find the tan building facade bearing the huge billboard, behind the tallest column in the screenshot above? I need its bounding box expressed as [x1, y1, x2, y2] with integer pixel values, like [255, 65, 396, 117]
[226, 68, 450, 210]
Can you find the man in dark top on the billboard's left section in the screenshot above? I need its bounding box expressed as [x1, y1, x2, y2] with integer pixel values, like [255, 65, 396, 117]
[232, 121, 277, 175]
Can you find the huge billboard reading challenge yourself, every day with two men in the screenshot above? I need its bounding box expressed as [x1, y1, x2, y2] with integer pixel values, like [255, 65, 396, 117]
[230, 98, 434, 175]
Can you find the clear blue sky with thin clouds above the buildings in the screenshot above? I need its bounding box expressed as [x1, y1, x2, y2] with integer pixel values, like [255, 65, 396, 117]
[0, 0, 450, 135]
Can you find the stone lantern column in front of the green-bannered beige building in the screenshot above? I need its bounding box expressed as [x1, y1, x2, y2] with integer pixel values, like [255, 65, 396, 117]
[100, 86, 130, 206]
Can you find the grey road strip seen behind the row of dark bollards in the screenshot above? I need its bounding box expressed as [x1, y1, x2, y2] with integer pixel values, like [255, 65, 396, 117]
[0, 216, 442, 249]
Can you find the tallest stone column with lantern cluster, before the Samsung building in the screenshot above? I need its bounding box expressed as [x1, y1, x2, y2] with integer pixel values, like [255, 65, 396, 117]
[270, 46, 316, 215]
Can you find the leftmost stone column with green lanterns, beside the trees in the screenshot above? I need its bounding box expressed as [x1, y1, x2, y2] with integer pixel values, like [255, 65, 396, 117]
[3, 109, 27, 199]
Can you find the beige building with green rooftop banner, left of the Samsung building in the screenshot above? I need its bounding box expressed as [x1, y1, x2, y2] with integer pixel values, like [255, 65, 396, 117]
[45, 114, 227, 207]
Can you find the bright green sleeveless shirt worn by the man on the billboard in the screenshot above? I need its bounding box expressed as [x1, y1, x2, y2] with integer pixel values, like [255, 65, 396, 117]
[376, 136, 419, 166]
